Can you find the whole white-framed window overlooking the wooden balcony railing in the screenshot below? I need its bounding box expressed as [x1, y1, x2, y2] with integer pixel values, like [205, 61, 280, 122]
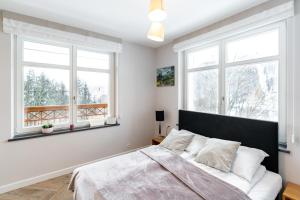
[16, 37, 114, 133]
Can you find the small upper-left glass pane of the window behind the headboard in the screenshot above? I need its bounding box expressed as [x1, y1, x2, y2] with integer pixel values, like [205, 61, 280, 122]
[187, 46, 219, 69]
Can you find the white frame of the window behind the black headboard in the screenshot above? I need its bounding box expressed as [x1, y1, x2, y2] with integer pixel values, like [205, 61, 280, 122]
[179, 21, 287, 141]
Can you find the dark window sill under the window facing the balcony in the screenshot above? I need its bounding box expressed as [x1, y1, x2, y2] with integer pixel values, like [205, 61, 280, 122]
[8, 124, 120, 142]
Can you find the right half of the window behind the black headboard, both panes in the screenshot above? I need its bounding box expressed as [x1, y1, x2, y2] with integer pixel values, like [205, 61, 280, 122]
[224, 28, 280, 121]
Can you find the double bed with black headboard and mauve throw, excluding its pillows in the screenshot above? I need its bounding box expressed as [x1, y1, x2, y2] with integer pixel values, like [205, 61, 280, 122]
[70, 110, 282, 200]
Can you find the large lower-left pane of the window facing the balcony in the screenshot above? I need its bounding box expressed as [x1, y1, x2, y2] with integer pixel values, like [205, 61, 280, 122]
[24, 67, 70, 127]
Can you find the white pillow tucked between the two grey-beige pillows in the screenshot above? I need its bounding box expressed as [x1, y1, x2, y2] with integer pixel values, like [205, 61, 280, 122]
[180, 130, 208, 155]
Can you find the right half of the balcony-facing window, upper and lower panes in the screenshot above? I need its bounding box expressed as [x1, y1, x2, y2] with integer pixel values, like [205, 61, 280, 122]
[76, 49, 112, 122]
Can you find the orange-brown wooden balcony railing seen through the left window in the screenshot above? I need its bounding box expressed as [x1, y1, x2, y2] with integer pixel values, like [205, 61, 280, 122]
[24, 104, 108, 127]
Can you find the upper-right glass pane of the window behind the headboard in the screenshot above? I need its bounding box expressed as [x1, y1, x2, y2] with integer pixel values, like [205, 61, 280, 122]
[226, 29, 279, 63]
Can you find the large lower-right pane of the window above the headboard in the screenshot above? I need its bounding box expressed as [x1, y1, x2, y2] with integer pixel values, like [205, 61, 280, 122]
[226, 61, 278, 121]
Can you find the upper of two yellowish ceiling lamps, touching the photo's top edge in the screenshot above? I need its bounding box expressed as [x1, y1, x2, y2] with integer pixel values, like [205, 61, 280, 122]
[148, 0, 167, 22]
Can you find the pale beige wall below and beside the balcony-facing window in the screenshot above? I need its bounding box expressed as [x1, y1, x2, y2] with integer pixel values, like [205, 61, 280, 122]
[0, 32, 155, 190]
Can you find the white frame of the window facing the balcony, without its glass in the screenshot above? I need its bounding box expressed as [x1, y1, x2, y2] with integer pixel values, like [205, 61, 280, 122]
[14, 35, 117, 135]
